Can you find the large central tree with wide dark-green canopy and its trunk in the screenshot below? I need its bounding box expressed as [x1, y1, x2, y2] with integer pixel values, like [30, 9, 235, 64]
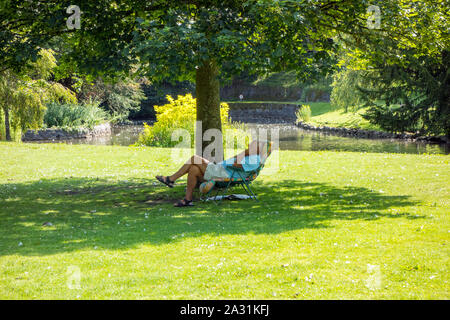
[6, 0, 367, 158]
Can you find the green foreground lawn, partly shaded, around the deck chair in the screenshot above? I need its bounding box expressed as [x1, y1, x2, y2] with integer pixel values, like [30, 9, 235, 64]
[0, 143, 450, 299]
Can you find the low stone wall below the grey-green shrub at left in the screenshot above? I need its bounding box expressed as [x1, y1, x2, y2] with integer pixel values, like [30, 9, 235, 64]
[22, 123, 111, 141]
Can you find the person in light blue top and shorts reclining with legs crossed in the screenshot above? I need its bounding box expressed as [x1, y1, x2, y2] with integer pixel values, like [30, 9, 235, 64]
[156, 140, 267, 207]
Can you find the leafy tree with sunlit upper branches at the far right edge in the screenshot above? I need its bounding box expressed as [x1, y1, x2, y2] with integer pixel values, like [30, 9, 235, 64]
[340, 0, 450, 137]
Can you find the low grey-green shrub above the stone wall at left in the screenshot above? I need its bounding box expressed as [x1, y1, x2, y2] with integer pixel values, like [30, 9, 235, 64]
[44, 103, 108, 128]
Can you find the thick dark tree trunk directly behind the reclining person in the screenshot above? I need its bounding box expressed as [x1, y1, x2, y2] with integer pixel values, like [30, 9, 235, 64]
[195, 60, 223, 162]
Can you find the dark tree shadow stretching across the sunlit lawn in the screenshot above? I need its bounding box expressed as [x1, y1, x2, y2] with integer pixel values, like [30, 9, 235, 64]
[0, 178, 424, 255]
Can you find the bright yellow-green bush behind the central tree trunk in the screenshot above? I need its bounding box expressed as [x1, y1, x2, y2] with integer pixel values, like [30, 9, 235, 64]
[136, 94, 248, 148]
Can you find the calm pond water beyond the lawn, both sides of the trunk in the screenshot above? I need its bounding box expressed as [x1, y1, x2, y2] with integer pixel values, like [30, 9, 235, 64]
[39, 124, 450, 154]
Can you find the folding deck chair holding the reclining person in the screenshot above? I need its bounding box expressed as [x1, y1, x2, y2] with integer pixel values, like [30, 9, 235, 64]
[200, 142, 273, 202]
